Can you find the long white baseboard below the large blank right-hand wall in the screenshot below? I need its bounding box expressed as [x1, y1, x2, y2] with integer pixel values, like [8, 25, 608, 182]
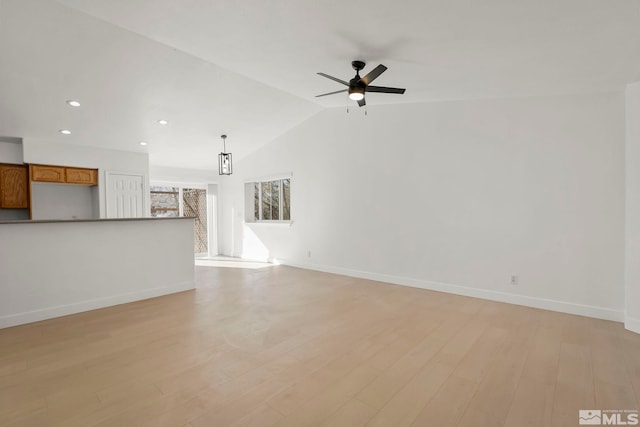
[281, 260, 624, 324]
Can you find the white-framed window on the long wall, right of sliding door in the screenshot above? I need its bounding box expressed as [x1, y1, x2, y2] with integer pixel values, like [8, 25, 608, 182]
[246, 178, 291, 222]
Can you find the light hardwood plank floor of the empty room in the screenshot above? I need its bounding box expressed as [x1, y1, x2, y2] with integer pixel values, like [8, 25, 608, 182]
[0, 266, 640, 427]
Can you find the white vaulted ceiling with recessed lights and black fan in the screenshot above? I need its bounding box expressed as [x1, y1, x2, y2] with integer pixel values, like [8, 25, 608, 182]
[0, 0, 640, 169]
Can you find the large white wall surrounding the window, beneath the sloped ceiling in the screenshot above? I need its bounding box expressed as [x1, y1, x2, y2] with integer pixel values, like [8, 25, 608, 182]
[222, 93, 625, 320]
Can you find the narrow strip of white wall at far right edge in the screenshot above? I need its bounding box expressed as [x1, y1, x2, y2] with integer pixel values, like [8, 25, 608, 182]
[625, 82, 640, 333]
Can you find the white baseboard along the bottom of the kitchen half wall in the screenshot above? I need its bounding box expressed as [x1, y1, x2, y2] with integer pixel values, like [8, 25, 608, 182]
[0, 282, 195, 329]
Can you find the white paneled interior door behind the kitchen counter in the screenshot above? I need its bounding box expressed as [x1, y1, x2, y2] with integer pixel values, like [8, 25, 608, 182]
[106, 172, 144, 218]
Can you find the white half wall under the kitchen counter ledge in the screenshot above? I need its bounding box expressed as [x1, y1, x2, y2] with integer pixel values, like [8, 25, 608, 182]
[0, 218, 194, 328]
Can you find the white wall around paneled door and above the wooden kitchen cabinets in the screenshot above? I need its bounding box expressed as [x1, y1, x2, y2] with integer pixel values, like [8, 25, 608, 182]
[23, 138, 150, 218]
